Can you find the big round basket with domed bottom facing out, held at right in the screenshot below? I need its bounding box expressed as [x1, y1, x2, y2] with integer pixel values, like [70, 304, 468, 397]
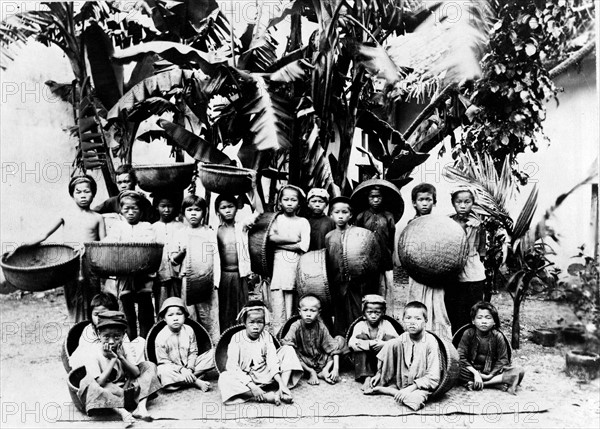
[398, 215, 469, 285]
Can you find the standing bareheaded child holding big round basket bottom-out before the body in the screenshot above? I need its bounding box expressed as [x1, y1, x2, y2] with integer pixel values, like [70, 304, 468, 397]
[408, 183, 452, 339]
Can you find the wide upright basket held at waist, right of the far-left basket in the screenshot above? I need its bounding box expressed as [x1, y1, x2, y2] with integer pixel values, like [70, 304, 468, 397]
[85, 241, 164, 277]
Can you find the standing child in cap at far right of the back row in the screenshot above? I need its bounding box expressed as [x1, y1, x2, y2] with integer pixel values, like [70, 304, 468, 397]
[445, 186, 486, 334]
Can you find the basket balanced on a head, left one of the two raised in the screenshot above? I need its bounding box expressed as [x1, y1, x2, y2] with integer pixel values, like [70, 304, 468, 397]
[134, 162, 196, 192]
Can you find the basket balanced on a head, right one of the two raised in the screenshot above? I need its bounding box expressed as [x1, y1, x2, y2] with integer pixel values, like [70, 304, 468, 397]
[198, 164, 256, 195]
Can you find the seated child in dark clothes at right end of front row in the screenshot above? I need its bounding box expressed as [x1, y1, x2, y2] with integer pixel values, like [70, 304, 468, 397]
[458, 301, 525, 395]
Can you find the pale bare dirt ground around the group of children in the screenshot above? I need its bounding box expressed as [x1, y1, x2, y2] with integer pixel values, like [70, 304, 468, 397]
[0, 282, 600, 428]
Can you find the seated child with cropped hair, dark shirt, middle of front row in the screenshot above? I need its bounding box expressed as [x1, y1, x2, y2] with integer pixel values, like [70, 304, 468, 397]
[281, 294, 346, 385]
